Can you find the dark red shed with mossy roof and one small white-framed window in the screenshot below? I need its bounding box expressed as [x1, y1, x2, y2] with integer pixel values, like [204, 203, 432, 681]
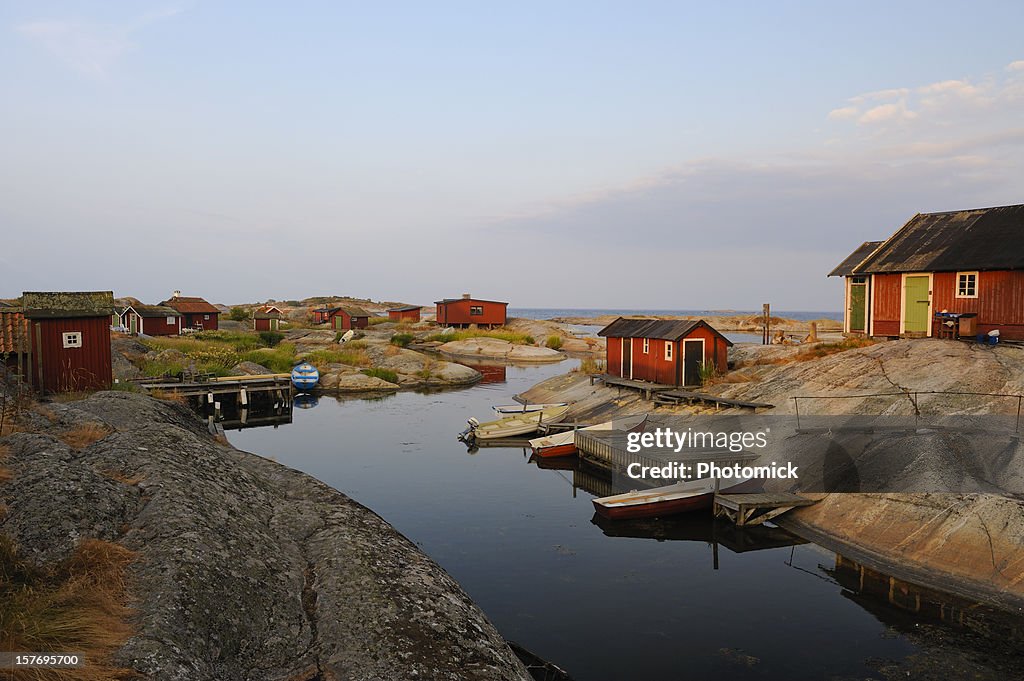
[22, 291, 114, 392]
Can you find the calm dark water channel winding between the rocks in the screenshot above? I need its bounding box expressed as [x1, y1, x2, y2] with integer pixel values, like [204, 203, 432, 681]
[228, 360, 1022, 681]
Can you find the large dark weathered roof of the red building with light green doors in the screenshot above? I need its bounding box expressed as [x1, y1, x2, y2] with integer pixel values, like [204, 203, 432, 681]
[835, 204, 1024, 274]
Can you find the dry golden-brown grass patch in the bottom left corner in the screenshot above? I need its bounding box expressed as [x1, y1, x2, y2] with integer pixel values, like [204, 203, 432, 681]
[0, 536, 138, 681]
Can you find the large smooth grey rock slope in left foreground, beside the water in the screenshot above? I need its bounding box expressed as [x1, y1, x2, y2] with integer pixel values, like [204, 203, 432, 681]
[0, 392, 528, 681]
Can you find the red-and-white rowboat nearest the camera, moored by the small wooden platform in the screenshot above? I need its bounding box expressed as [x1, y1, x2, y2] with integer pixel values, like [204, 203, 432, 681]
[593, 477, 761, 520]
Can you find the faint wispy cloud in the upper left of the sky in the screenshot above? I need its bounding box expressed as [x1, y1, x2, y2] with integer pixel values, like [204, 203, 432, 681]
[15, 8, 181, 78]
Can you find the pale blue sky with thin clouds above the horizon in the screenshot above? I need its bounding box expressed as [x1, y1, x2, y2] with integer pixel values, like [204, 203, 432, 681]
[0, 0, 1024, 310]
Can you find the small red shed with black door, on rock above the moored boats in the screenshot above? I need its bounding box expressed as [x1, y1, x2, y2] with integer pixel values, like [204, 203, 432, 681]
[597, 317, 732, 386]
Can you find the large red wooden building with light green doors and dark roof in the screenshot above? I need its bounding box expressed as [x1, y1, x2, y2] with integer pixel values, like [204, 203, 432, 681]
[828, 205, 1024, 340]
